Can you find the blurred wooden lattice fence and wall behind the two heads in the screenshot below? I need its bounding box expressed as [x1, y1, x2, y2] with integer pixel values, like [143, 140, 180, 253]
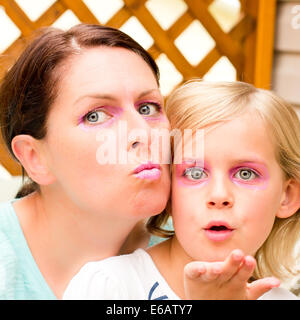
[0, 0, 300, 201]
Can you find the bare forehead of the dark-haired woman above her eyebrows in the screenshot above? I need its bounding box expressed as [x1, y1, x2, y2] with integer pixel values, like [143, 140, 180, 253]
[52, 47, 160, 107]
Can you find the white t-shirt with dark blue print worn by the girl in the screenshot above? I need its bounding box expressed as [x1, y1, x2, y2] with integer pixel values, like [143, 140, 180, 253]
[63, 249, 299, 300]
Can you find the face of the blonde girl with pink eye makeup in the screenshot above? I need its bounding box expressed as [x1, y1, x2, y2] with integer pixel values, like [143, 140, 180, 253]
[172, 114, 284, 261]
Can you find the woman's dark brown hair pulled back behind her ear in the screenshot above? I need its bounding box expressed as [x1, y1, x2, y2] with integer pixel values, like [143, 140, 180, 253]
[0, 24, 159, 198]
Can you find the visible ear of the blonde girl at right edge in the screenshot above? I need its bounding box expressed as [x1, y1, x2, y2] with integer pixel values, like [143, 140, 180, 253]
[276, 179, 300, 218]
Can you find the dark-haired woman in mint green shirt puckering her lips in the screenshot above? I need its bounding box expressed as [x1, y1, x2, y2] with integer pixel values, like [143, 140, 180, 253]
[0, 25, 170, 299]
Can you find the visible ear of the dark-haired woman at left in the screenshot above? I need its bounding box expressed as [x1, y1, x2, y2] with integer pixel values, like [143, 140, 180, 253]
[11, 134, 55, 185]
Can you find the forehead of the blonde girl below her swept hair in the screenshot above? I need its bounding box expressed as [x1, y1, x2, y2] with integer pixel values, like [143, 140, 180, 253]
[174, 114, 276, 160]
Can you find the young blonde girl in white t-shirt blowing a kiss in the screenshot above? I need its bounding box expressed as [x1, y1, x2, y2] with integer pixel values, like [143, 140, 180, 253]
[64, 80, 300, 299]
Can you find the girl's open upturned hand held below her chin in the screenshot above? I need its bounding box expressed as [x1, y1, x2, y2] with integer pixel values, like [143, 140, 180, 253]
[184, 250, 280, 300]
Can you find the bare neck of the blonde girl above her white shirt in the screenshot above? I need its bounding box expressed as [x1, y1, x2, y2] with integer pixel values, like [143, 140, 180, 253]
[147, 236, 192, 299]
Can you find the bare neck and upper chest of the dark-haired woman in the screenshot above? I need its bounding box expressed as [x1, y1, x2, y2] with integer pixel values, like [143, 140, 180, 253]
[14, 192, 137, 298]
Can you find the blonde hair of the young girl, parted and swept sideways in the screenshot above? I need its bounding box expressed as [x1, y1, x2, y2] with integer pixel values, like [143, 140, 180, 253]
[147, 80, 300, 278]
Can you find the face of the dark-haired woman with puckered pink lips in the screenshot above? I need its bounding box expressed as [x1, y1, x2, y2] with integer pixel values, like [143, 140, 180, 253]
[43, 47, 170, 218]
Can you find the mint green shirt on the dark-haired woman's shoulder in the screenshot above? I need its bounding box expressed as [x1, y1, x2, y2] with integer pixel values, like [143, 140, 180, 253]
[0, 200, 56, 300]
